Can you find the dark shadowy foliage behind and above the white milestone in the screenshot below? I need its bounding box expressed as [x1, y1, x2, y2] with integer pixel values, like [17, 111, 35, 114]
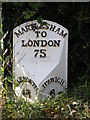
[2, 2, 90, 88]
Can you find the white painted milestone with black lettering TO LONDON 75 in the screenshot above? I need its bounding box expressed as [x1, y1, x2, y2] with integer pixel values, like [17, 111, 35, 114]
[13, 20, 68, 99]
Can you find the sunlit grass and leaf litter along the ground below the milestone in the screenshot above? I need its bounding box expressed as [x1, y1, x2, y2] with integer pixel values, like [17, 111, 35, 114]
[2, 81, 90, 120]
